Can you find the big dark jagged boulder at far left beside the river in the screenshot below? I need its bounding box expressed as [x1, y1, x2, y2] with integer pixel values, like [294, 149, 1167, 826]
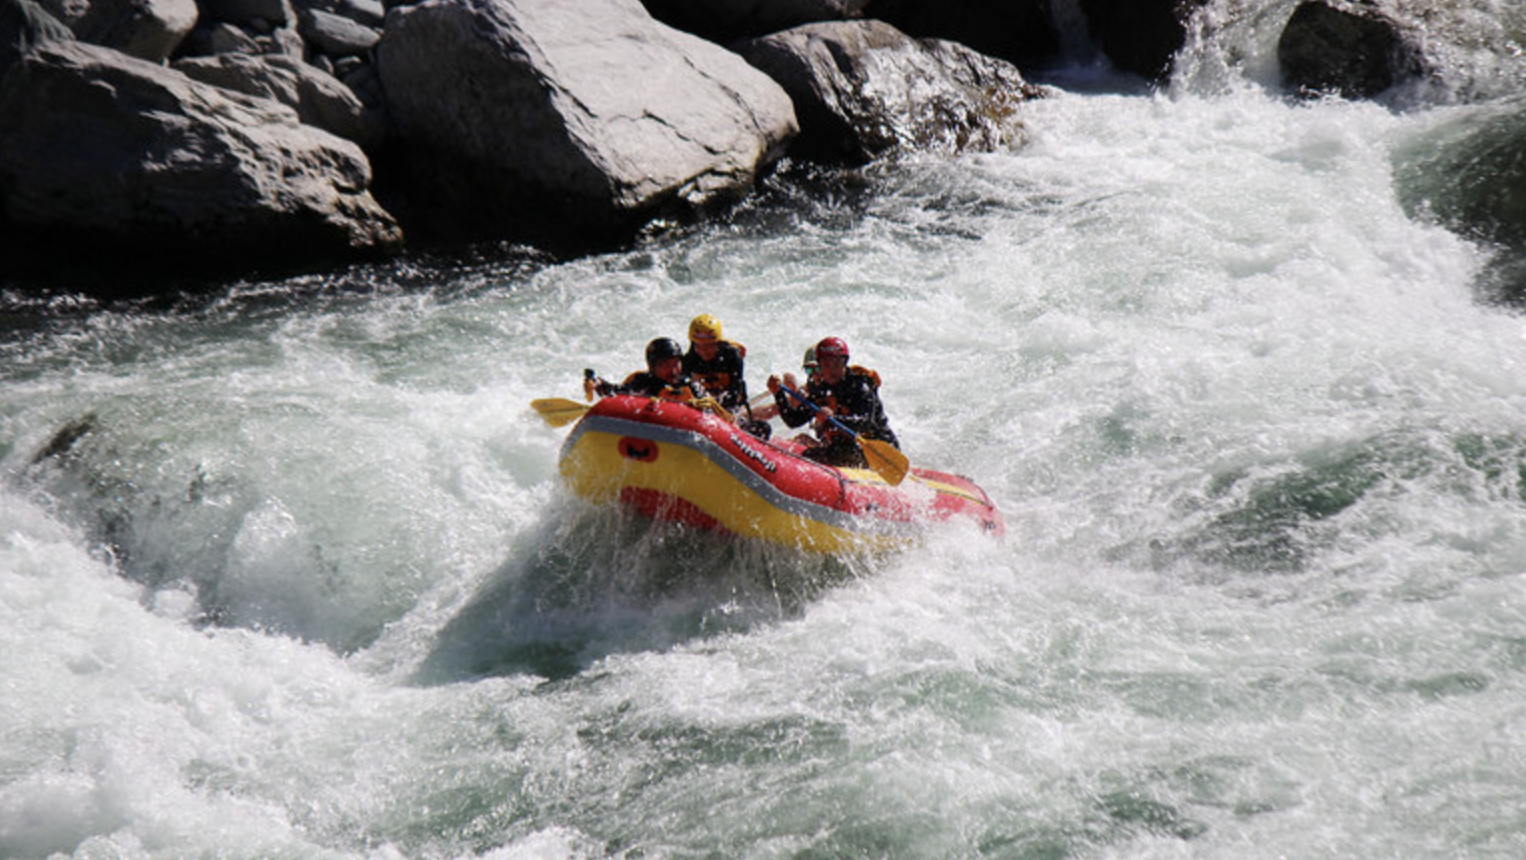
[0, 41, 401, 261]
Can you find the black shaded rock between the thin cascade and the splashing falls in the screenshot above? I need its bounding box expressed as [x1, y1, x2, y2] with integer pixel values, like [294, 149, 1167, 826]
[1080, 0, 1207, 81]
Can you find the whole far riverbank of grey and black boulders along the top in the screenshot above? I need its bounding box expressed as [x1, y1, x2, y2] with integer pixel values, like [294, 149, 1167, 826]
[0, 0, 1464, 292]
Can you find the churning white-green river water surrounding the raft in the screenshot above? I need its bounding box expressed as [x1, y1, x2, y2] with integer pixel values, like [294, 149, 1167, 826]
[0, 5, 1526, 860]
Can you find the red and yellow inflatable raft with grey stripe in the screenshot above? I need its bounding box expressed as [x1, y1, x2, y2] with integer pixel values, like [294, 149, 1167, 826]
[560, 396, 1006, 552]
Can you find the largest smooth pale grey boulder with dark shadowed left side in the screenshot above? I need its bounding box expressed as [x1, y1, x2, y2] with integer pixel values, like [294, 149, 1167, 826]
[377, 0, 797, 235]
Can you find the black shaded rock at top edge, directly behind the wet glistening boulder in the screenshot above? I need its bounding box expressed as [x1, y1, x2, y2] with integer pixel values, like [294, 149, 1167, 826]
[864, 0, 1061, 69]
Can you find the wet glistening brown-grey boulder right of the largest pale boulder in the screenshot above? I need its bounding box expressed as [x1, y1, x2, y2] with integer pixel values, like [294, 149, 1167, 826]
[737, 21, 1039, 163]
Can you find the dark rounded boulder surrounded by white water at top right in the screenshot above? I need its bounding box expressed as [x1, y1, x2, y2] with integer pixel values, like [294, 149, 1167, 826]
[1277, 0, 1425, 98]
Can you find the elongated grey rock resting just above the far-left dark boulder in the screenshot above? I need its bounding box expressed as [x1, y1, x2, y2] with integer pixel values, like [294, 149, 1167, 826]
[174, 53, 382, 148]
